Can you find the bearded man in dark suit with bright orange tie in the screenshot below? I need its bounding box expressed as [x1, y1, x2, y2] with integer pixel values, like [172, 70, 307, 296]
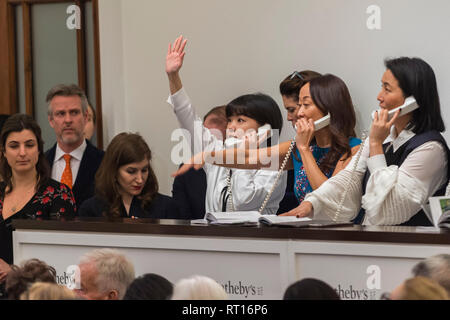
[45, 85, 104, 208]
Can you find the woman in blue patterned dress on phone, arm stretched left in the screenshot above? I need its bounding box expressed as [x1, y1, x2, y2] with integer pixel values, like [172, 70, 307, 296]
[175, 74, 361, 214]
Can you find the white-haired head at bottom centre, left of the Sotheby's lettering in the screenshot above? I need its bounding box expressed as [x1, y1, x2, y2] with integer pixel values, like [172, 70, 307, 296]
[172, 276, 228, 300]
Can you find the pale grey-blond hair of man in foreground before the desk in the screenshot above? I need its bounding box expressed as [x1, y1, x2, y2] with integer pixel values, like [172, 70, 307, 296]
[80, 249, 134, 299]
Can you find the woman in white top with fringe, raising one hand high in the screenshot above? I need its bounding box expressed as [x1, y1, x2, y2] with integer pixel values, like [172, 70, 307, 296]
[166, 36, 286, 214]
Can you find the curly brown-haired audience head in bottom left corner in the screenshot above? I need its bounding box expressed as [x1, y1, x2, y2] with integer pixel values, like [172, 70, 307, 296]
[5, 259, 56, 300]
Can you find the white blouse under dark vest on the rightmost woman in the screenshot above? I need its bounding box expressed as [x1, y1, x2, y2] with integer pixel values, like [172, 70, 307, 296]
[304, 126, 448, 225]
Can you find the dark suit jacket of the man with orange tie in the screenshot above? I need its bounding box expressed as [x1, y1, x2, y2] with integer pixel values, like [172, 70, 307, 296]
[45, 140, 105, 208]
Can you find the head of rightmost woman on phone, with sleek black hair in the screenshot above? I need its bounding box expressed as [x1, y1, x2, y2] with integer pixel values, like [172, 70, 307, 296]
[378, 57, 445, 134]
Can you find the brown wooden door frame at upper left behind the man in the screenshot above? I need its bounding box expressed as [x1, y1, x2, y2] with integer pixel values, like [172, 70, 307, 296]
[0, 0, 103, 149]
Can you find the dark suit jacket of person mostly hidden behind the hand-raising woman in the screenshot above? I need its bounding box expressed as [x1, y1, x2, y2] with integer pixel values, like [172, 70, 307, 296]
[172, 165, 206, 220]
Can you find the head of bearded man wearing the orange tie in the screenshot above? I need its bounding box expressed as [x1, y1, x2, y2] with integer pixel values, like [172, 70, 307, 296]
[46, 84, 88, 152]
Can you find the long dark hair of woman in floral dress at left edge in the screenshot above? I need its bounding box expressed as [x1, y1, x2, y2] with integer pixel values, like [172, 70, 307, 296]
[0, 113, 50, 193]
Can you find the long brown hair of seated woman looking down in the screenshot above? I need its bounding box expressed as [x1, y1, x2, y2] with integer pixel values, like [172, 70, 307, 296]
[95, 132, 159, 217]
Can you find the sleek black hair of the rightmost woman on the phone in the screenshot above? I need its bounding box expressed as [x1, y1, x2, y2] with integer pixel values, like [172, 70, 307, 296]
[384, 57, 445, 134]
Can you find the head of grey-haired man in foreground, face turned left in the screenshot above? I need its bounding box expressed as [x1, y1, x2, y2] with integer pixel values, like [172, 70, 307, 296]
[76, 249, 134, 300]
